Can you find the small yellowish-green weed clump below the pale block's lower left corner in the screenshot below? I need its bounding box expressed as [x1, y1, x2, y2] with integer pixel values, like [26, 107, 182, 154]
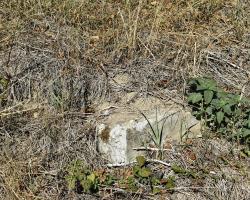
[65, 160, 99, 193]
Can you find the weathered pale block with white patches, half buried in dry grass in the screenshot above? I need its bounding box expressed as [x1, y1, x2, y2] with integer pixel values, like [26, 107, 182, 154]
[97, 97, 201, 163]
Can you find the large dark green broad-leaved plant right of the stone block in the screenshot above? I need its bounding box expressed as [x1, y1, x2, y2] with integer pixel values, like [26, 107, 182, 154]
[187, 78, 250, 144]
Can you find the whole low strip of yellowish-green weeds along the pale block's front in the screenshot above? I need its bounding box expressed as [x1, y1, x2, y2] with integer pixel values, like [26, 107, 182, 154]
[65, 156, 179, 194]
